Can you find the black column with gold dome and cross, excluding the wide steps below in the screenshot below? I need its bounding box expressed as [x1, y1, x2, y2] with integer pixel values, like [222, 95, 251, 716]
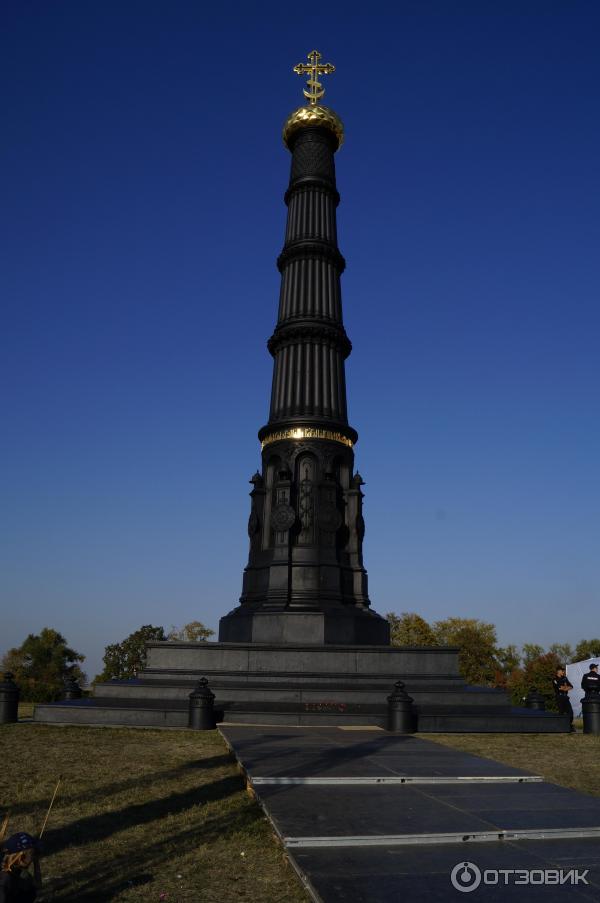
[219, 50, 389, 645]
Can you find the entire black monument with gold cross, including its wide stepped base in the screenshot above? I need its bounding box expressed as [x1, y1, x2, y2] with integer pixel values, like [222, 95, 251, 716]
[34, 51, 569, 732]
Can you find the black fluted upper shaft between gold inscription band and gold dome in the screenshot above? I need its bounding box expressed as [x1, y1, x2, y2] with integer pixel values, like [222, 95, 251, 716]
[262, 128, 351, 427]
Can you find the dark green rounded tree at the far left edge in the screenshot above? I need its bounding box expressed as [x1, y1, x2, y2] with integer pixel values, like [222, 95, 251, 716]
[1, 627, 86, 702]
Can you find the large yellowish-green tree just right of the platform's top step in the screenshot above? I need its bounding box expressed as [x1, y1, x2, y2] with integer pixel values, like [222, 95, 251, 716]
[433, 618, 499, 686]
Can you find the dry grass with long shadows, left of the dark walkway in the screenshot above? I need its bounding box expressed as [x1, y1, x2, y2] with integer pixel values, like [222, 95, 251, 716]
[0, 723, 308, 903]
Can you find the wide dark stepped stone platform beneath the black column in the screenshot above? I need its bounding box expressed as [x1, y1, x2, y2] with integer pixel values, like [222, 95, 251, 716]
[34, 642, 569, 733]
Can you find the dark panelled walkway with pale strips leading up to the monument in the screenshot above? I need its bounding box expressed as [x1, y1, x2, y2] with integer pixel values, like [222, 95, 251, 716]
[220, 724, 600, 903]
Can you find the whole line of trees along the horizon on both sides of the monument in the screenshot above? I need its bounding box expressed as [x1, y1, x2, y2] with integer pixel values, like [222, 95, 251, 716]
[0, 612, 600, 710]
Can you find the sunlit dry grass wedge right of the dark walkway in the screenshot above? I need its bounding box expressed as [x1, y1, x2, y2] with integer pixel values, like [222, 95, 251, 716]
[428, 734, 600, 796]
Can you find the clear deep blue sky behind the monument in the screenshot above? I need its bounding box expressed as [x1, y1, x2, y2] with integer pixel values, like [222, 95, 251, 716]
[0, 0, 600, 676]
